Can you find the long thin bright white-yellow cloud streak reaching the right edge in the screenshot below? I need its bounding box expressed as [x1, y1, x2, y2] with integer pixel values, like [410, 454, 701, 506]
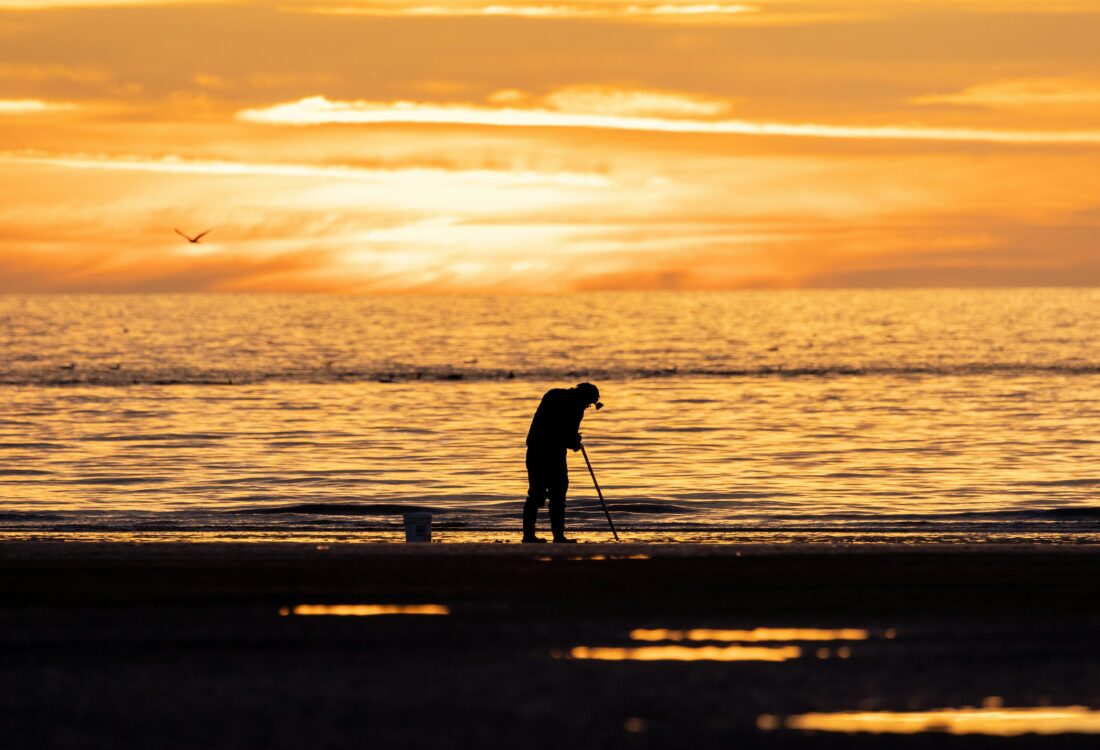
[238, 96, 1100, 144]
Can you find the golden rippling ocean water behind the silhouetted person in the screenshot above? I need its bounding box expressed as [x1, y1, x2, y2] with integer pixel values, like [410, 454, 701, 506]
[0, 289, 1100, 543]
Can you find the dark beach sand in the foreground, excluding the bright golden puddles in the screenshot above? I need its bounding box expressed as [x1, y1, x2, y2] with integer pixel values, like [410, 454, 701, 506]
[0, 541, 1100, 749]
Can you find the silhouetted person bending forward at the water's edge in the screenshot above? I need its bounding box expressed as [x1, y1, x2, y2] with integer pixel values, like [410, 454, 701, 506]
[524, 383, 603, 543]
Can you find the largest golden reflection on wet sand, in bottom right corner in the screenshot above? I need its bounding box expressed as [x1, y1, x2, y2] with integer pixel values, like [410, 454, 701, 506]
[770, 706, 1100, 737]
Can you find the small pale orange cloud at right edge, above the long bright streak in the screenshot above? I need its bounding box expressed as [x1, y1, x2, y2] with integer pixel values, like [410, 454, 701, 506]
[910, 78, 1100, 109]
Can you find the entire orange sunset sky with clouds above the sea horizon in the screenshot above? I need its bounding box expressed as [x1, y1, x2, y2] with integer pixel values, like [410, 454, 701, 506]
[0, 0, 1100, 293]
